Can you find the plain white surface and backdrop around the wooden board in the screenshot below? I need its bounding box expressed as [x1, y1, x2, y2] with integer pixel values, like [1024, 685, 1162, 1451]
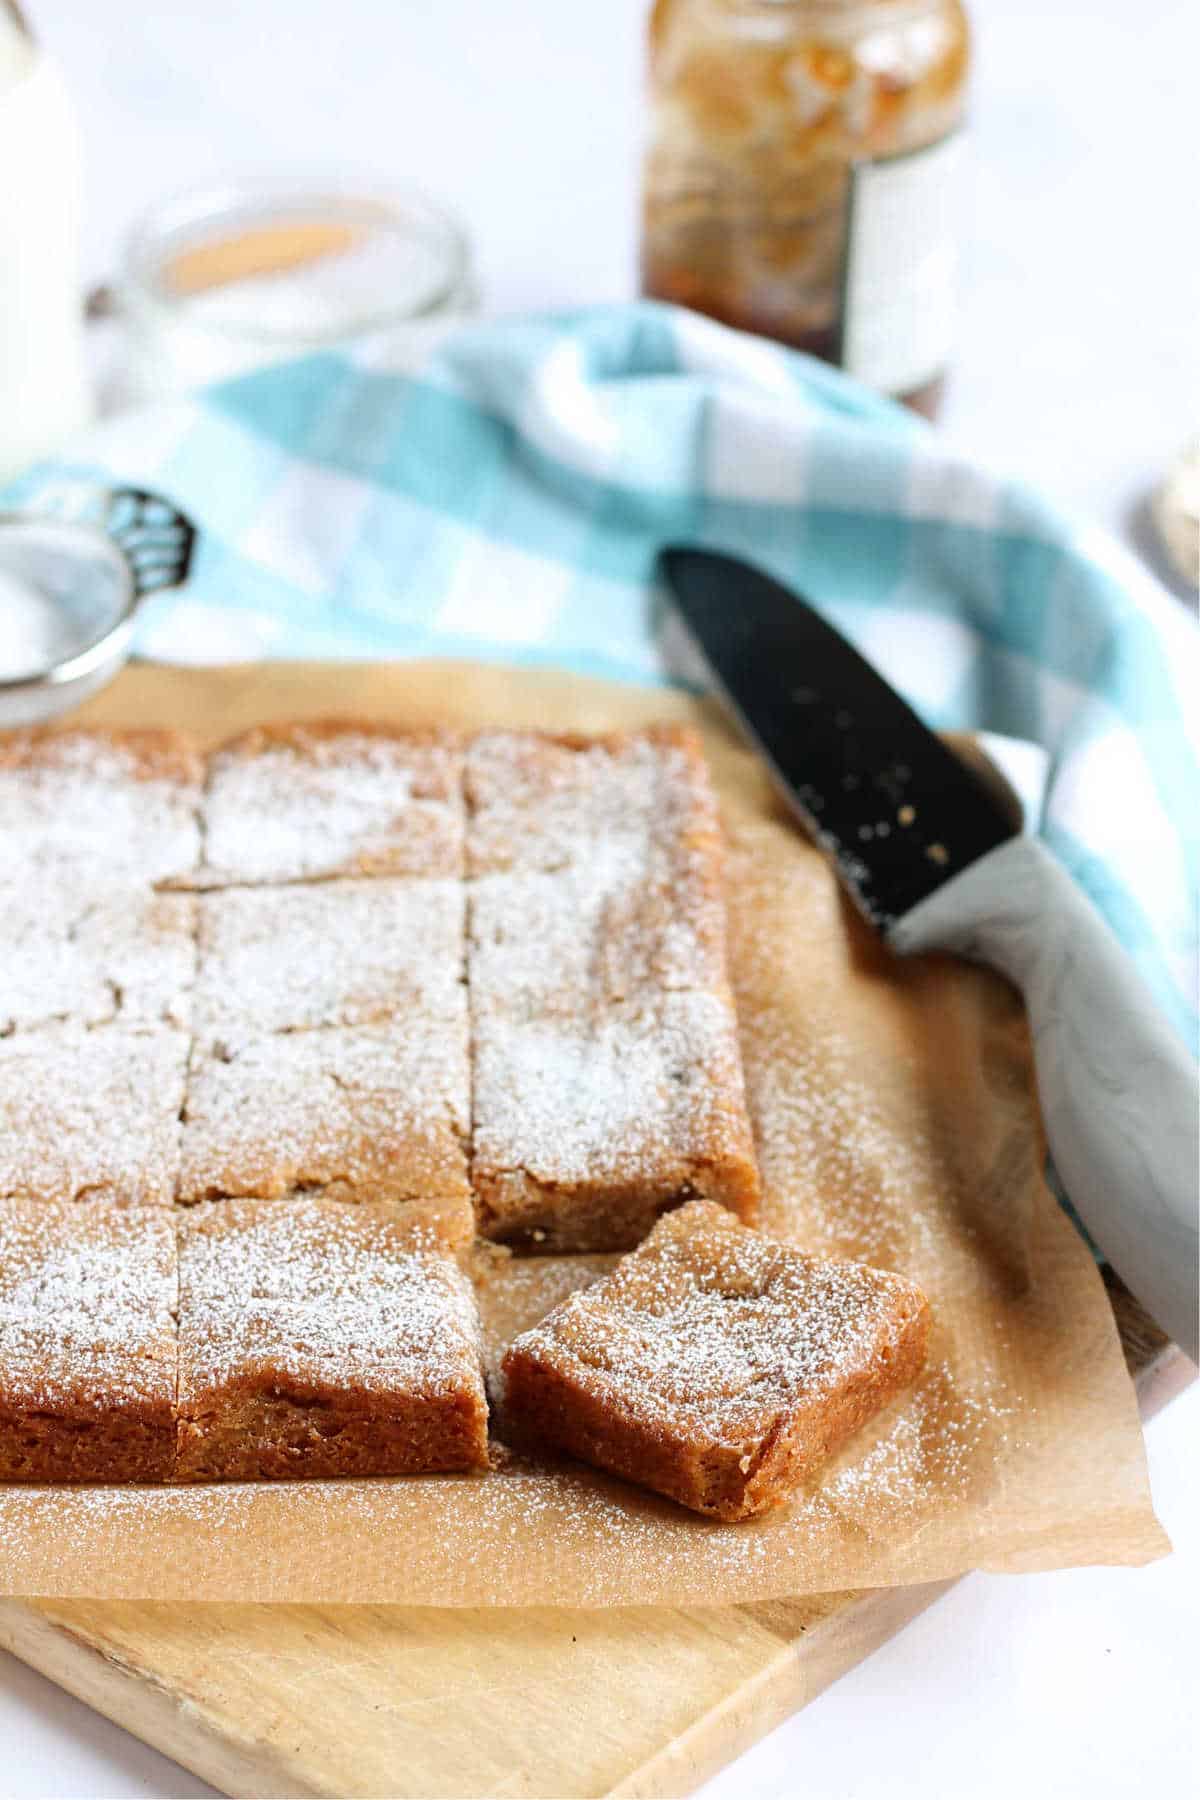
[9, 0, 1200, 1800]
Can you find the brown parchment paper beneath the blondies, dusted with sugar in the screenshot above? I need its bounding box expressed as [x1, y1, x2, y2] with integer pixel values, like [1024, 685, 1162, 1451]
[0, 662, 1169, 1606]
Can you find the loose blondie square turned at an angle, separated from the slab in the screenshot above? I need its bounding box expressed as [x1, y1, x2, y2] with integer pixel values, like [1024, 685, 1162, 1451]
[502, 1201, 930, 1519]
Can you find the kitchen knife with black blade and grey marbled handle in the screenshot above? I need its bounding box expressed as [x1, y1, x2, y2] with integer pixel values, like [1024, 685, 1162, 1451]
[660, 547, 1200, 1363]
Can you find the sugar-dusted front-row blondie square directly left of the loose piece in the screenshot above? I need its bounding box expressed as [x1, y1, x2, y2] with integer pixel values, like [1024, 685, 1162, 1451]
[175, 1199, 488, 1481]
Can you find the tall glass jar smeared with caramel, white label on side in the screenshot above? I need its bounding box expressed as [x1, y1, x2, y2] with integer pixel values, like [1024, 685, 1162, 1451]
[642, 0, 968, 410]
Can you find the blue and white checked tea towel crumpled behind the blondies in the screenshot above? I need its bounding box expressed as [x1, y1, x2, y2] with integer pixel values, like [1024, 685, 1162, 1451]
[7, 304, 1200, 1040]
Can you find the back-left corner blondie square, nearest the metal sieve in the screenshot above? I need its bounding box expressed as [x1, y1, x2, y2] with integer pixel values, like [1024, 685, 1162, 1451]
[0, 731, 203, 889]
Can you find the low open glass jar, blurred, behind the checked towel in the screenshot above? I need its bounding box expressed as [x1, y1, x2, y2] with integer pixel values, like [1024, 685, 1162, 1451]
[108, 180, 477, 403]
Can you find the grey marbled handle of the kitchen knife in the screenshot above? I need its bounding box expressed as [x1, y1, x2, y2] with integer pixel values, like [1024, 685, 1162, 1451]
[889, 837, 1200, 1363]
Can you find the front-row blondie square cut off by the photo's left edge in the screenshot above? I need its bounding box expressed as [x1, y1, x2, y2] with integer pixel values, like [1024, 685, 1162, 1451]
[0, 1199, 176, 1481]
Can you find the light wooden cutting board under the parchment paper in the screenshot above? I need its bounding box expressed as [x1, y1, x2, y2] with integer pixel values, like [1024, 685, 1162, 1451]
[0, 1282, 1195, 1800]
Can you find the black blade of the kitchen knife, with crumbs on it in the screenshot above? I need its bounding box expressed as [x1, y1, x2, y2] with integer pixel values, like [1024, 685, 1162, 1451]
[658, 547, 1015, 931]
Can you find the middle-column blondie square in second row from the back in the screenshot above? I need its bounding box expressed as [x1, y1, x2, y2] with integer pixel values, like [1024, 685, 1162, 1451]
[194, 878, 464, 1046]
